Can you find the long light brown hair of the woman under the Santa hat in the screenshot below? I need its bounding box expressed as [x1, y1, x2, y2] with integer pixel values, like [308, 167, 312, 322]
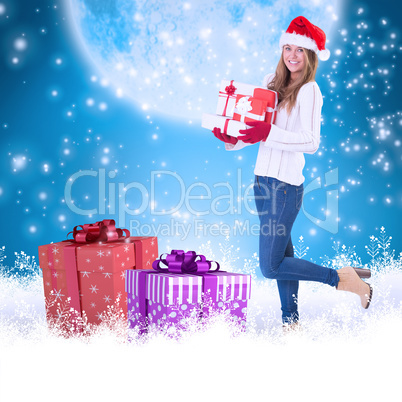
[267, 48, 318, 113]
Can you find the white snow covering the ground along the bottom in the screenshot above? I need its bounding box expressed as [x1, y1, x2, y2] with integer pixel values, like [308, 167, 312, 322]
[0, 271, 402, 402]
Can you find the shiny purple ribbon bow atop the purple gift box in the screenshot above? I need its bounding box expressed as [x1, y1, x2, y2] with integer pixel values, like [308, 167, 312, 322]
[152, 250, 219, 274]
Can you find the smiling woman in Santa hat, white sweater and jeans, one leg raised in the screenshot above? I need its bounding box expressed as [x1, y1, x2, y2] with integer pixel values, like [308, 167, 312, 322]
[213, 16, 372, 329]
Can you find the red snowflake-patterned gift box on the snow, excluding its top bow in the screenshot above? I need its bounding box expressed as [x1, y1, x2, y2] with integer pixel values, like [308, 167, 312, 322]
[39, 221, 158, 330]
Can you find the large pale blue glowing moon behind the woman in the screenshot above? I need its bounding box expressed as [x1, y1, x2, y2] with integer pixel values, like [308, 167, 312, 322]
[66, 0, 341, 120]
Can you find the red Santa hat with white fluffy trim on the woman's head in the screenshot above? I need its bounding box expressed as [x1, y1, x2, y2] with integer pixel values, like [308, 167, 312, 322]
[279, 16, 330, 60]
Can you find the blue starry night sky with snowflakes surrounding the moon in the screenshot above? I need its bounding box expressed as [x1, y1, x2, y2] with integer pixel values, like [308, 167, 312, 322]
[0, 0, 402, 274]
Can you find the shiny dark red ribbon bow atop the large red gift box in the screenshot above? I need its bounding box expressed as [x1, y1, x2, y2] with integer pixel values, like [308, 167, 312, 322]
[67, 219, 130, 243]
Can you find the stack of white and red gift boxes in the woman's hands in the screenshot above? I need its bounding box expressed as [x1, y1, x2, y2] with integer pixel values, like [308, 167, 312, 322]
[202, 80, 278, 137]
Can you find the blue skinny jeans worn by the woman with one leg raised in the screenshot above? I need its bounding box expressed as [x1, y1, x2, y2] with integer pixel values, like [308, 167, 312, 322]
[254, 176, 339, 323]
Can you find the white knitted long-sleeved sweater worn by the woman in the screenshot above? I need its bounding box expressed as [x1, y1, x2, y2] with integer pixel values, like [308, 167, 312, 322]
[225, 74, 323, 186]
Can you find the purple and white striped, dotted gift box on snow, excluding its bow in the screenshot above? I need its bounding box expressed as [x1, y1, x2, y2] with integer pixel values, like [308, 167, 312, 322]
[126, 262, 251, 333]
